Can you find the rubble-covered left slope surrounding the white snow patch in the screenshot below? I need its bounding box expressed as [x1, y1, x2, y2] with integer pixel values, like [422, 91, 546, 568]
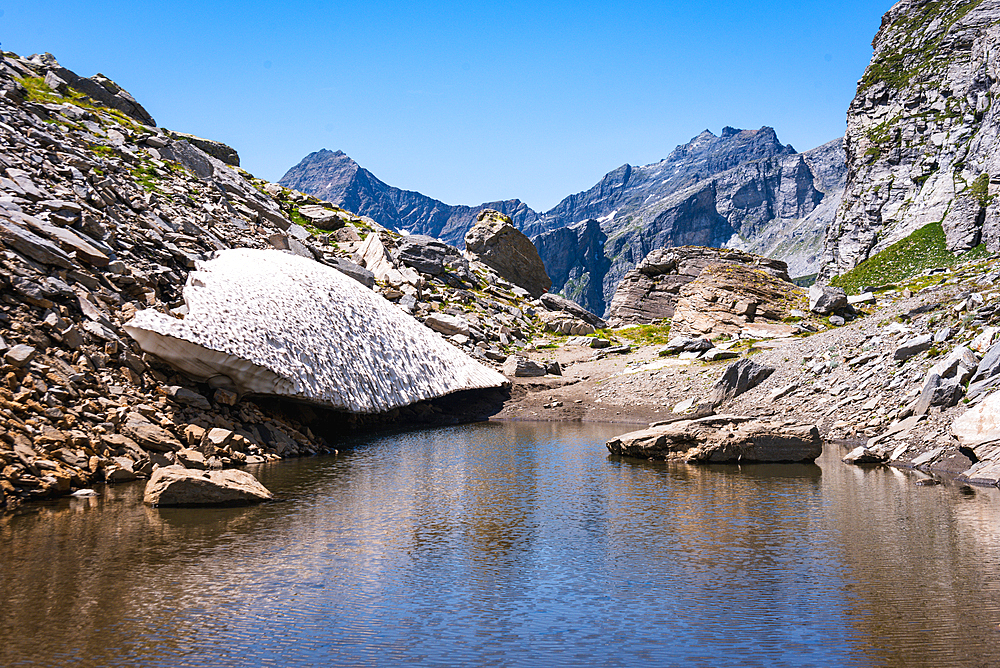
[0, 53, 594, 507]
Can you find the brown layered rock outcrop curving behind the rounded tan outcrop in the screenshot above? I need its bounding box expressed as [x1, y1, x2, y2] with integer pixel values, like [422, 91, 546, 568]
[607, 246, 793, 327]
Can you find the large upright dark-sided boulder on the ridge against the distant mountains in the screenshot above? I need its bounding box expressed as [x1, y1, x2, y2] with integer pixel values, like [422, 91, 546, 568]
[465, 209, 552, 298]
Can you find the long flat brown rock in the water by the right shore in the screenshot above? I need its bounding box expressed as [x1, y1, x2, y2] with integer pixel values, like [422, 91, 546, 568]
[607, 415, 823, 463]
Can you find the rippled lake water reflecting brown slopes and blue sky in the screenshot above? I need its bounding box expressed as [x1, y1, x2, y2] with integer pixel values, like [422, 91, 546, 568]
[0, 423, 1000, 666]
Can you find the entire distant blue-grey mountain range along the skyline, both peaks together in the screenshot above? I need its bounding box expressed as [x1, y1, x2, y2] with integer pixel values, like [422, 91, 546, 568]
[280, 127, 846, 313]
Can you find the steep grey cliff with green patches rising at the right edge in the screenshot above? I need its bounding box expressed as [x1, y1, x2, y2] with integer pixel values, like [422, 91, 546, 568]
[822, 0, 1000, 277]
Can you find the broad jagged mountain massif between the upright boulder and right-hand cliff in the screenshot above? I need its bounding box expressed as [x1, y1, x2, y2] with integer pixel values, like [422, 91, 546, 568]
[526, 128, 845, 313]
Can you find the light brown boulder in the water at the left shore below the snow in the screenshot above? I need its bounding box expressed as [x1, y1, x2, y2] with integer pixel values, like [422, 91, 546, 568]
[142, 466, 274, 506]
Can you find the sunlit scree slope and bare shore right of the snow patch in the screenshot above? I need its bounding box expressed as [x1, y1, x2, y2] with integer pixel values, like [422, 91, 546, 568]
[500, 250, 1000, 486]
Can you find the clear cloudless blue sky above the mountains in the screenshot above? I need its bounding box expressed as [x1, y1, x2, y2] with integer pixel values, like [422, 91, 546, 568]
[0, 0, 892, 211]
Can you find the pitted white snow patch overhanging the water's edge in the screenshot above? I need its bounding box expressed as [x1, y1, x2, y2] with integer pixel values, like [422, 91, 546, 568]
[125, 249, 506, 413]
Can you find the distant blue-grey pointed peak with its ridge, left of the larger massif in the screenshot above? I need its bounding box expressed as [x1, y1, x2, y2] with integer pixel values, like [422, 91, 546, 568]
[278, 149, 538, 246]
